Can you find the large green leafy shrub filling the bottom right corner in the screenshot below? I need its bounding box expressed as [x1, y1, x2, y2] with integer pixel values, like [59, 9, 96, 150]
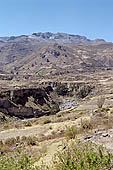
[53, 142, 113, 170]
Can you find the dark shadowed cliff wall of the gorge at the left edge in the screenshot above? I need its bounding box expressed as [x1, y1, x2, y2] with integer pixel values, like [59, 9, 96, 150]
[0, 86, 56, 119]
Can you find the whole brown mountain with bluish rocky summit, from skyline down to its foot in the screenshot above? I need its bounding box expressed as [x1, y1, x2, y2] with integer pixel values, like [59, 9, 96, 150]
[0, 32, 113, 75]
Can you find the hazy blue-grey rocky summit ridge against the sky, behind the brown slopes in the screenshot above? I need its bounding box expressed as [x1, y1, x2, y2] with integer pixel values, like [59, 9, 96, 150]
[0, 32, 105, 44]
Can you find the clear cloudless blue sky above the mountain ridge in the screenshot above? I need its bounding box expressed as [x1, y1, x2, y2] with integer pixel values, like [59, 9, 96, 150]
[0, 0, 113, 41]
